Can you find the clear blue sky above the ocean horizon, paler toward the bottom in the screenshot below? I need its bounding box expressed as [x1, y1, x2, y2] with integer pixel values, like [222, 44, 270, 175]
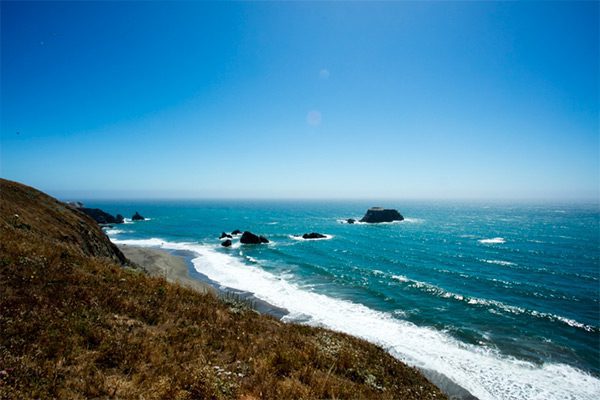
[0, 1, 600, 199]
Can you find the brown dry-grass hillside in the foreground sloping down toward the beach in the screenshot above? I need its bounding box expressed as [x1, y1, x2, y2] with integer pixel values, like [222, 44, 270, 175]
[0, 180, 445, 399]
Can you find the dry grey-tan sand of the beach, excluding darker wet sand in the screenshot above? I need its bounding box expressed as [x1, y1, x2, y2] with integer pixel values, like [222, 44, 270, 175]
[119, 244, 217, 294]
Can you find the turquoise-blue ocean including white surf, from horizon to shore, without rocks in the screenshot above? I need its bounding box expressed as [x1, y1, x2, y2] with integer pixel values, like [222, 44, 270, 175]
[86, 200, 600, 399]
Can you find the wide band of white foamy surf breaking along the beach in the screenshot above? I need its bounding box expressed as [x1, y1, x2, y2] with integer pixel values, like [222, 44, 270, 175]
[110, 239, 600, 400]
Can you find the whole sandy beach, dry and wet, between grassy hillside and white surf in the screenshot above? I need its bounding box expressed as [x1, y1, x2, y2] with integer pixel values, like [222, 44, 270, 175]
[118, 244, 478, 400]
